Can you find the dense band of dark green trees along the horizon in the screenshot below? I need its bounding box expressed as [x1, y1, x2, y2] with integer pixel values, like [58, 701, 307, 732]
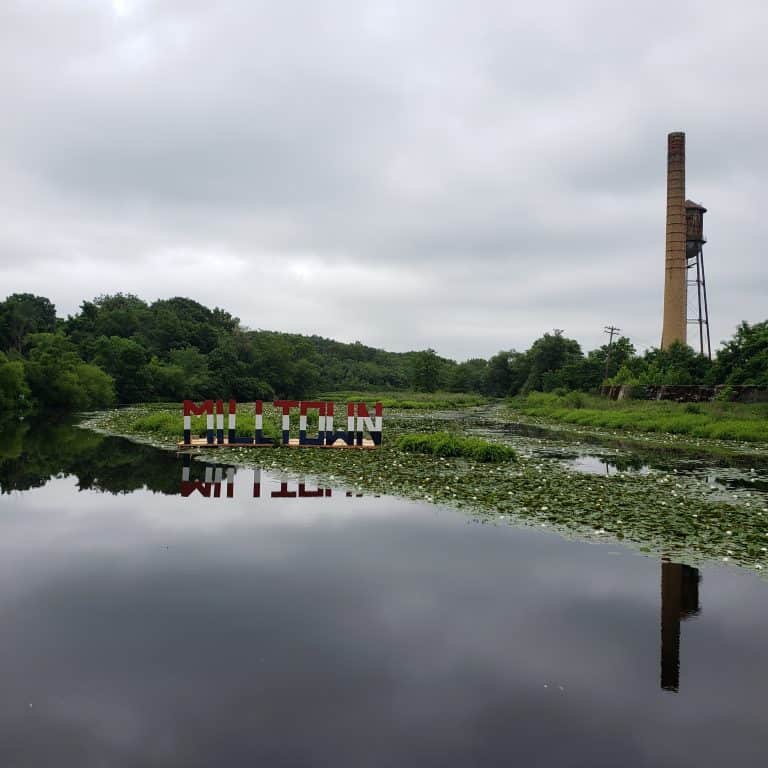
[0, 293, 768, 413]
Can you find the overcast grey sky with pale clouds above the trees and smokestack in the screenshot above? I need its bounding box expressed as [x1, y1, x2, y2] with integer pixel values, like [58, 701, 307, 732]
[0, 0, 768, 359]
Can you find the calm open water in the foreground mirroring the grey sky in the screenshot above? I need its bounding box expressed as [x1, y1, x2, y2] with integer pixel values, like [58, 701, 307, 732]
[0, 425, 768, 768]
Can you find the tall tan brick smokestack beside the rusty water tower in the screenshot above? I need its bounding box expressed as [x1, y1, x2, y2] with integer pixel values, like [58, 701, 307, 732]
[661, 133, 688, 349]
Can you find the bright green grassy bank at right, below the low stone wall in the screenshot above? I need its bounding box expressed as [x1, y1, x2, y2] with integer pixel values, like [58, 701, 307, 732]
[509, 393, 768, 442]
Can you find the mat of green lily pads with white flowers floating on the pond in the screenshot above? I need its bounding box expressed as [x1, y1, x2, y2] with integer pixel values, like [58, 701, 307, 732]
[83, 405, 768, 571]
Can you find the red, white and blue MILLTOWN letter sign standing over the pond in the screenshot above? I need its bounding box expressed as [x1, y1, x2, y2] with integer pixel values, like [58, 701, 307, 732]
[179, 400, 382, 448]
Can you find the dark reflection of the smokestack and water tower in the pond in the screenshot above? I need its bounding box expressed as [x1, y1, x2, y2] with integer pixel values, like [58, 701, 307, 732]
[661, 562, 700, 691]
